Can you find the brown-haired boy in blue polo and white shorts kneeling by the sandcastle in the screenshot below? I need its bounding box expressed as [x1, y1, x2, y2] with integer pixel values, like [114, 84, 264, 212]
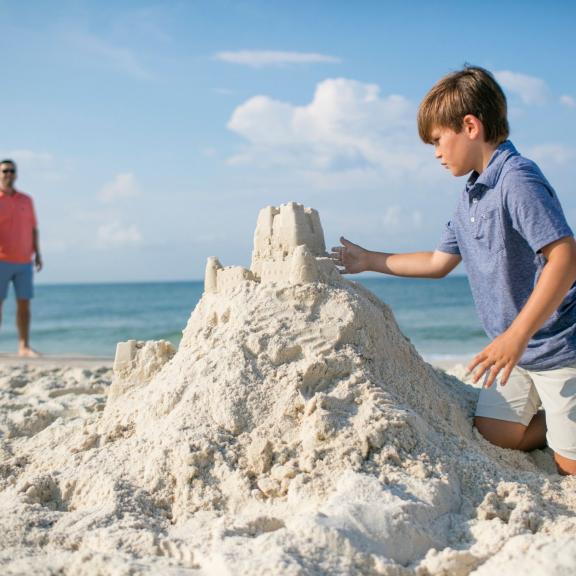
[331, 66, 576, 474]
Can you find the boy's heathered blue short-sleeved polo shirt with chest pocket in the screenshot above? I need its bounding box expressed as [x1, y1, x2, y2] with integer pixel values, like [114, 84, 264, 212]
[437, 141, 576, 370]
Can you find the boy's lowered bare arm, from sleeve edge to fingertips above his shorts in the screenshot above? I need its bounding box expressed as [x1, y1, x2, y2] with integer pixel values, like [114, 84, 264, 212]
[468, 236, 576, 388]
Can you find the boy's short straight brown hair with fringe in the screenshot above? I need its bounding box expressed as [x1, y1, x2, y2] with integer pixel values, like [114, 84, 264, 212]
[418, 65, 510, 144]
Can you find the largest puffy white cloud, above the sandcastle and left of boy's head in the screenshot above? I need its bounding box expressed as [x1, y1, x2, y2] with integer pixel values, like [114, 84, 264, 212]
[228, 78, 432, 184]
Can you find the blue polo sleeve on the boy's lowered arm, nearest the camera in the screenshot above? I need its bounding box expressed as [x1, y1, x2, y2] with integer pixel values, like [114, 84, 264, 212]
[503, 167, 574, 252]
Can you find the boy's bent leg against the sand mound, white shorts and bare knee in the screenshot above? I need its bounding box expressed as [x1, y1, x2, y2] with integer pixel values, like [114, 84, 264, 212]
[474, 367, 546, 451]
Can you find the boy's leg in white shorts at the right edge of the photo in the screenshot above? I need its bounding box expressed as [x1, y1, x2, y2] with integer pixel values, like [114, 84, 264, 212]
[531, 364, 576, 474]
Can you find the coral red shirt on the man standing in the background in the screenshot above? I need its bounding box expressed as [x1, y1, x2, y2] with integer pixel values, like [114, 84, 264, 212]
[0, 190, 37, 264]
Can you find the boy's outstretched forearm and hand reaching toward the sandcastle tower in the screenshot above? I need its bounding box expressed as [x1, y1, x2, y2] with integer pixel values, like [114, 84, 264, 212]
[330, 237, 462, 278]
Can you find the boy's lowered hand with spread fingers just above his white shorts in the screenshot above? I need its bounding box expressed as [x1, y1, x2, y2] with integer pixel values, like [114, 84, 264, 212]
[468, 329, 528, 388]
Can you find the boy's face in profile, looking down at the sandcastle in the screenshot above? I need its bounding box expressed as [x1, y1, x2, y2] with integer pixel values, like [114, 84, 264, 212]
[431, 127, 478, 176]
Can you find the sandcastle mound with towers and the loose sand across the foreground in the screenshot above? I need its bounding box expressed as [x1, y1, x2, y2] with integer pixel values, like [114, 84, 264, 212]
[0, 204, 576, 576]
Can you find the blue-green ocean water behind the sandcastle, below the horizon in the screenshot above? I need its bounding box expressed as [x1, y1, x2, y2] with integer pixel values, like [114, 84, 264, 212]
[0, 276, 488, 360]
